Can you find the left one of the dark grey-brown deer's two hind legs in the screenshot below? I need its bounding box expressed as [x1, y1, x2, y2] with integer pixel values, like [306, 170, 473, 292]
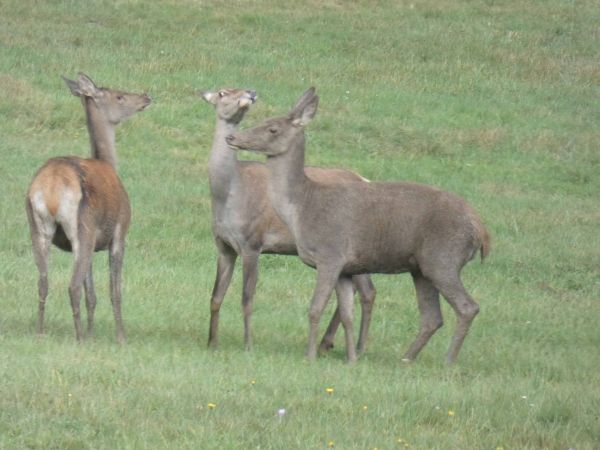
[402, 273, 443, 361]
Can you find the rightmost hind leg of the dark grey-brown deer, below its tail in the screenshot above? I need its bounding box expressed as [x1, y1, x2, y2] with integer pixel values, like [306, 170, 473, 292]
[438, 274, 479, 364]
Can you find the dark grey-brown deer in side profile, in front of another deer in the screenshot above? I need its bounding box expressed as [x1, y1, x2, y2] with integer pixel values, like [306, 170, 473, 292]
[226, 87, 490, 364]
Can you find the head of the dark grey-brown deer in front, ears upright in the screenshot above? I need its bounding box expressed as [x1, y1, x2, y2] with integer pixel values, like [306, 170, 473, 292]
[227, 87, 319, 156]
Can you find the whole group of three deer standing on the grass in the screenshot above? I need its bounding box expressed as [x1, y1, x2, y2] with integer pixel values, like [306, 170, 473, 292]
[26, 73, 490, 363]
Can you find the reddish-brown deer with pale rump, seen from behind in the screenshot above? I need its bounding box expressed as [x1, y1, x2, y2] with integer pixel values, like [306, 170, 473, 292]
[25, 73, 151, 343]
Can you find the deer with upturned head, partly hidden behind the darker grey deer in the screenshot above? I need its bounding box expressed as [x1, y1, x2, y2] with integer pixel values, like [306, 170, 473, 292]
[199, 89, 376, 353]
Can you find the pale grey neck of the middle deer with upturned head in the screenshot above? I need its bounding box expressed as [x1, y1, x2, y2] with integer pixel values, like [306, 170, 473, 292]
[208, 119, 239, 196]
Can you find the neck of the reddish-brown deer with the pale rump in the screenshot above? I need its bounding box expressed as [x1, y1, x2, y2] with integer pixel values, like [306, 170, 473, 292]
[85, 99, 117, 170]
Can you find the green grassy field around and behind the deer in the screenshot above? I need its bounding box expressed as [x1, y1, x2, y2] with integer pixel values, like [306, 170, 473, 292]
[0, 0, 600, 450]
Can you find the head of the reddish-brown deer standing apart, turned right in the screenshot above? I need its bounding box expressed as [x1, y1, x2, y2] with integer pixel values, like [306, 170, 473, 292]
[62, 73, 152, 125]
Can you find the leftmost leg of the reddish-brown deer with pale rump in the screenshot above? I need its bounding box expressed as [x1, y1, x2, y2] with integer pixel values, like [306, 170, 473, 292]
[26, 199, 56, 335]
